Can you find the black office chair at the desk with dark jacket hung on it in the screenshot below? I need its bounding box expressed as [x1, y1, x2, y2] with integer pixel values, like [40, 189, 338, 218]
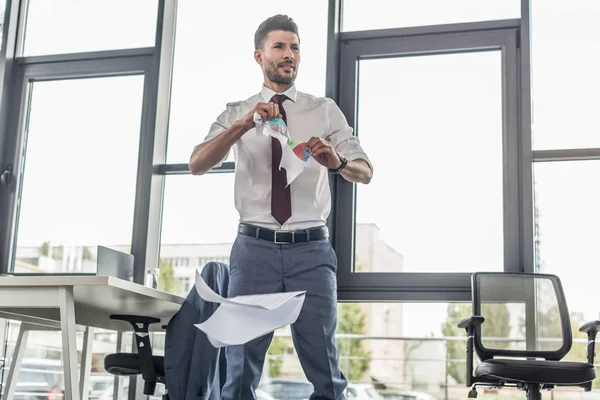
[104, 315, 169, 400]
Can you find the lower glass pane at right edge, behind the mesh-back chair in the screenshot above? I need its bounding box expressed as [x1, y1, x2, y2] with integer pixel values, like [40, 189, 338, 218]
[534, 161, 600, 364]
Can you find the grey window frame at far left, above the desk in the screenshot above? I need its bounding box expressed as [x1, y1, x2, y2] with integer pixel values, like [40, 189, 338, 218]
[0, 0, 177, 290]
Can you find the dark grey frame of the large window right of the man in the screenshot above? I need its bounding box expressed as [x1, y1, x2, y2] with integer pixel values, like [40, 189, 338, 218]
[333, 20, 528, 301]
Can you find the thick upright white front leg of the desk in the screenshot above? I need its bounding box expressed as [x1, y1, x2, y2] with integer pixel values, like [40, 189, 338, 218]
[58, 286, 79, 400]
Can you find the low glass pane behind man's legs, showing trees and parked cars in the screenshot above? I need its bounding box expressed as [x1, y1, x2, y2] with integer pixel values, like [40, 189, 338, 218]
[260, 303, 482, 400]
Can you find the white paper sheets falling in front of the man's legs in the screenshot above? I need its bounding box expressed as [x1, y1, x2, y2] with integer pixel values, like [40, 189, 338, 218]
[195, 270, 306, 348]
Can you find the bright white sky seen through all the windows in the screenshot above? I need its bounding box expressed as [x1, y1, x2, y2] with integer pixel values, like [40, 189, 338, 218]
[0, 0, 600, 336]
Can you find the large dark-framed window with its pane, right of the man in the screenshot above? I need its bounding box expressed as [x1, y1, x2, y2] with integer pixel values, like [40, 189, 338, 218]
[334, 21, 523, 301]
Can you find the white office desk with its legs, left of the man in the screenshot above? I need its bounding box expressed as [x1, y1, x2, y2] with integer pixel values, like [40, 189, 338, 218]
[0, 276, 185, 400]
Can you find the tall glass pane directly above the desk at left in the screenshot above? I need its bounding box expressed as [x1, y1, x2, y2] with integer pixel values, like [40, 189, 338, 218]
[15, 76, 144, 273]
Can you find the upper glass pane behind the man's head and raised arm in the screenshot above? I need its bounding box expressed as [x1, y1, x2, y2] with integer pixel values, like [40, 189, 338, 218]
[167, 0, 327, 163]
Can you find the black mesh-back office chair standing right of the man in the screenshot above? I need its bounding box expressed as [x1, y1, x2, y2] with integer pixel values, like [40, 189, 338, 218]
[458, 272, 600, 400]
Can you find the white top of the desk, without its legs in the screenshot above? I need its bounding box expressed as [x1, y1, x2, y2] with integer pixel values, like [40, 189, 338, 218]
[0, 275, 185, 331]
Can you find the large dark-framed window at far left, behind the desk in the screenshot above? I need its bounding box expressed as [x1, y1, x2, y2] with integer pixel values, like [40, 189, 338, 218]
[0, 0, 161, 398]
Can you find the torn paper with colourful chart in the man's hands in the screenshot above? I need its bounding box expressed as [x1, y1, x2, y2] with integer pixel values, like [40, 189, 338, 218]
[254, 113, 312, 186]
